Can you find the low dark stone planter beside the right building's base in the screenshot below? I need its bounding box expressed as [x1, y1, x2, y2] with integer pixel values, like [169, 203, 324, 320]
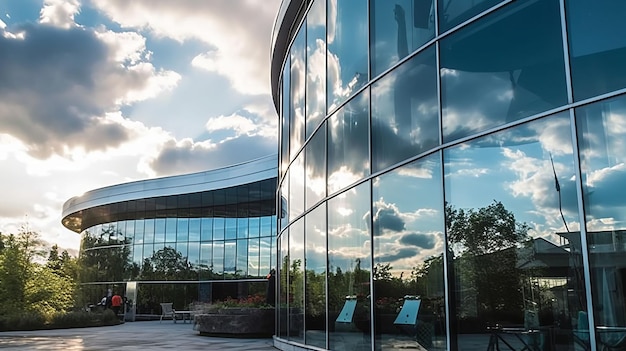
[194, 308, 275, 338]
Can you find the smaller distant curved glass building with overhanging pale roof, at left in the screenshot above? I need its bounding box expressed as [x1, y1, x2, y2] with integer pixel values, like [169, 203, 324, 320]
[62, 155, 278, 315]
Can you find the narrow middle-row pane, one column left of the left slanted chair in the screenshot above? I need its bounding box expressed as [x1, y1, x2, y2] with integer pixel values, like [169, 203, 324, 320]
[304, 123, 326, 212]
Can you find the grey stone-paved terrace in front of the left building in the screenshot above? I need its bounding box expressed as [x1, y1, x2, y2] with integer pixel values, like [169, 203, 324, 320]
[0, 320, 276, 351]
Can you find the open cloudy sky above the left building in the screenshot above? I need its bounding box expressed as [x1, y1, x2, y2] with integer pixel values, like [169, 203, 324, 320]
[0, 0, 280, 253]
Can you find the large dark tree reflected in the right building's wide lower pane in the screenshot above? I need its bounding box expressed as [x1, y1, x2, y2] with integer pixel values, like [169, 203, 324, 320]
[445, 200, 529, 323]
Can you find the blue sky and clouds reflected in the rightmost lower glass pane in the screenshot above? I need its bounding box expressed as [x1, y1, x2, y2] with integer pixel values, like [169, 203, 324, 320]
[576, 96, 626, 231]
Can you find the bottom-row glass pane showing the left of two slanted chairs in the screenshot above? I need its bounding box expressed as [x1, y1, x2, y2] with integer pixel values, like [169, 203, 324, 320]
[328, 182, 372, 350]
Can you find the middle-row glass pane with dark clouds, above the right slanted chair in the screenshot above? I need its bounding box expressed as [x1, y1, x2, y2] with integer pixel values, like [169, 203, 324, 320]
[372, 47, 439, 172]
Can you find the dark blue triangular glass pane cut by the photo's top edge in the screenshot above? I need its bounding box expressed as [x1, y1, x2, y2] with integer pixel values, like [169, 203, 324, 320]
[436, 0, 504, 32]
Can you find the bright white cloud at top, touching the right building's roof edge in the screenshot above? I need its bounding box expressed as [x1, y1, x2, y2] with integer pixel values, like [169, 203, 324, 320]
[93, 0, 279, 94]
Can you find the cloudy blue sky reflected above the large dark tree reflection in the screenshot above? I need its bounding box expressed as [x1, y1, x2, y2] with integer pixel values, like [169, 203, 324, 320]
[444, 113, 579, 245]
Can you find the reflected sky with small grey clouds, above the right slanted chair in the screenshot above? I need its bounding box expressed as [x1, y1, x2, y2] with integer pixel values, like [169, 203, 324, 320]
[372, 154, 444, 278]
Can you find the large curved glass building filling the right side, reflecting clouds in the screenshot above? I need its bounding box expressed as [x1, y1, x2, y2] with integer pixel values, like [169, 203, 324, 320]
[271, 0, 626, 350]
